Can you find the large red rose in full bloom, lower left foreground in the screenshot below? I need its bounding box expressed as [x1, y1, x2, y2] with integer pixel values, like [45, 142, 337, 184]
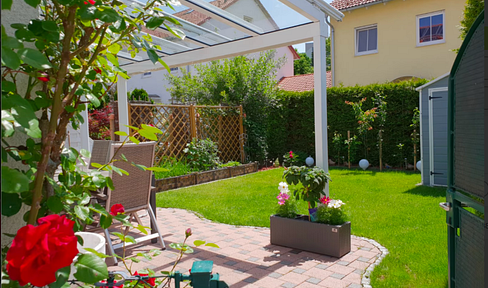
[6, 214, 78, 287]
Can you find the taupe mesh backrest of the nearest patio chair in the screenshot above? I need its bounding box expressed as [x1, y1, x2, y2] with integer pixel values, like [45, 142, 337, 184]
[107, 142, 156, 212]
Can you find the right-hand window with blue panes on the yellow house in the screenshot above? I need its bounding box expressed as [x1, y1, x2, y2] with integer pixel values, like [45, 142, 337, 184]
[417, 11, 446, 46]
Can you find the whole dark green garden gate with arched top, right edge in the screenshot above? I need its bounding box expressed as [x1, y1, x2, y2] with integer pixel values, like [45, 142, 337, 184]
[446, 11, 485, 288]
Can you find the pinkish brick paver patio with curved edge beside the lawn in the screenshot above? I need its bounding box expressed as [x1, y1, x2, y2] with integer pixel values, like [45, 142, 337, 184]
[109, 208, 388, 288]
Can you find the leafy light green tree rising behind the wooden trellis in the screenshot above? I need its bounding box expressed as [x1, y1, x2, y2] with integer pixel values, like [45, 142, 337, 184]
[166, 51, 284, 161]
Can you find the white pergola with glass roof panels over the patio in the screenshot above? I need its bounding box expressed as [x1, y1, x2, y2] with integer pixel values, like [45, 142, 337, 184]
[117, 0, 344, 195]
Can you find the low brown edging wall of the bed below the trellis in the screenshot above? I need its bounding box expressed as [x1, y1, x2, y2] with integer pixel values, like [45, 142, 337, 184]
[156, 162, 258, 192]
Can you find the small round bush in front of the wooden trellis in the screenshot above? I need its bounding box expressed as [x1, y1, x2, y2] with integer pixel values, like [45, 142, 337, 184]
[183, 138, 220, 171]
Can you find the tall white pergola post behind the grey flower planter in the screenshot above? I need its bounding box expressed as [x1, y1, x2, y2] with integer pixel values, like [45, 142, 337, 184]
[313, 19, 329, 196]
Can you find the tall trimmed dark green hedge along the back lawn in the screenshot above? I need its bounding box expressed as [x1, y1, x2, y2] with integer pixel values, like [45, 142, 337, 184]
[268, 80, 427, 167]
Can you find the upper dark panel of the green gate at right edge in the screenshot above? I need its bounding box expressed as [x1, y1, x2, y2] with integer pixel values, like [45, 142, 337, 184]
[453, 21, 484, 197]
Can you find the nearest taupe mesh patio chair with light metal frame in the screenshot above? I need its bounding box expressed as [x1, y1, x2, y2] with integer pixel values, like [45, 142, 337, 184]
[105, 142, 166, 264]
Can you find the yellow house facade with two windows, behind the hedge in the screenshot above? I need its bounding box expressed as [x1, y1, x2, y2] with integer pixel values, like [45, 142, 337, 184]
[331, 0, 466, 86]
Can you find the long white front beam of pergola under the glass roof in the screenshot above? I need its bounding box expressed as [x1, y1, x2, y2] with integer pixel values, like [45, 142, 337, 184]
[121, 23, 320, 75]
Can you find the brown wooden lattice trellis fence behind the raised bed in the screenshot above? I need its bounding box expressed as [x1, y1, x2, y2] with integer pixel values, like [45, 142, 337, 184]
[129, 103, 245, 165]
